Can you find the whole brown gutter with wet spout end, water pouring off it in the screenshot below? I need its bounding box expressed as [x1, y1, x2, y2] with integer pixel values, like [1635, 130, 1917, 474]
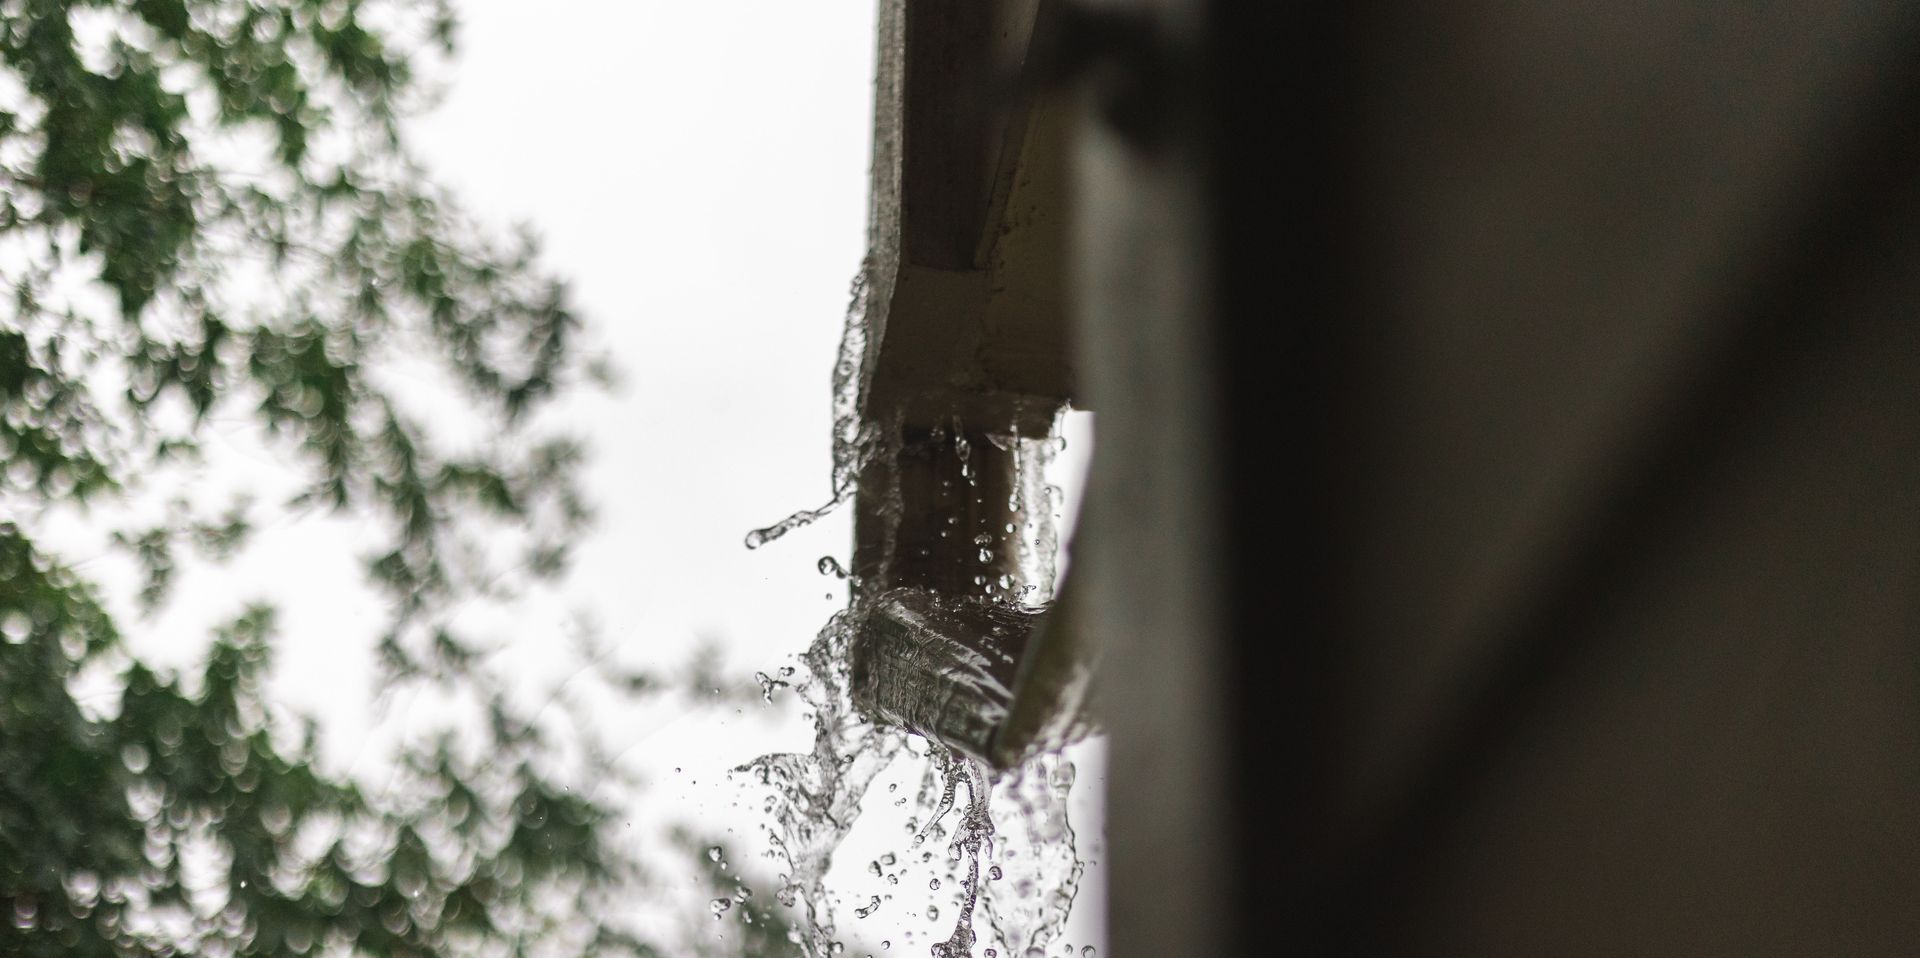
[849, 0, 1092, 768]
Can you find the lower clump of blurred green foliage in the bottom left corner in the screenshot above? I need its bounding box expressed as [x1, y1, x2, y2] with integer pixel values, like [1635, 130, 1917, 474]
[0, 526, 647, 956]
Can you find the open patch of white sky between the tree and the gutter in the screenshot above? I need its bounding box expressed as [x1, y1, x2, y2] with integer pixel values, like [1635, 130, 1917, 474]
[415, 0, 872, 675]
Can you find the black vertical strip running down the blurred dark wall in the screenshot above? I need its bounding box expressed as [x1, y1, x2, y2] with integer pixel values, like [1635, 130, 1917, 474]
[1192, 0, 1357, 956]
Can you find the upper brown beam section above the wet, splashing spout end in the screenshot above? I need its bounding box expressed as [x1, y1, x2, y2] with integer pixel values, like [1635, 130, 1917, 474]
[862, 0, 1073, 434]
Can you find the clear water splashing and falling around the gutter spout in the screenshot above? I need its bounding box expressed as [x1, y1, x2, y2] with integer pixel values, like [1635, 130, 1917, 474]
[735, 264, 1085, 958]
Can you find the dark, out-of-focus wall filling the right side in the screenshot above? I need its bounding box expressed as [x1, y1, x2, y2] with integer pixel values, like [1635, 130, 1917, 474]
[1075, 0, 1920, 956]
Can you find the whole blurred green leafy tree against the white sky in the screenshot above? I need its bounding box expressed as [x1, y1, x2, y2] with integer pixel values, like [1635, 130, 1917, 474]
[0, 0, 679, 956]
